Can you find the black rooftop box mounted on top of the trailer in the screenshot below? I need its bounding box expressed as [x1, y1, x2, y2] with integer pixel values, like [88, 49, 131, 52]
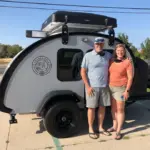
[41, 11, 117, 34]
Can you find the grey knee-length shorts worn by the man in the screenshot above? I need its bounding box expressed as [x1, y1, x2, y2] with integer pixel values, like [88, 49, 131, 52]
[86, 87, 111, 108]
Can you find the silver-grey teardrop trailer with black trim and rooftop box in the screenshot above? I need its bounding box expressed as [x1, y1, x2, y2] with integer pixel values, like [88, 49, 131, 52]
[0, 11, 150, 138]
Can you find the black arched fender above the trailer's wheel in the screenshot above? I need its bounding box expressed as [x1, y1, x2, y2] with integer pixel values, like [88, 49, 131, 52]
[36, 90, 81, 116]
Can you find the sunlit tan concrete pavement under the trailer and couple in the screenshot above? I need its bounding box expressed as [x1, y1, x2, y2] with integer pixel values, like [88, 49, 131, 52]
[0, 101, 150, 150]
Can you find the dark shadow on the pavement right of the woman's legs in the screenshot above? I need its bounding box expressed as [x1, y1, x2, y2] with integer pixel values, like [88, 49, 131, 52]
[123, 101, 150, 134]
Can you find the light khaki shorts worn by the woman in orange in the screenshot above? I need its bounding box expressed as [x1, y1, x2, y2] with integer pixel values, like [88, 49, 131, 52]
[109, 86, 126, 101]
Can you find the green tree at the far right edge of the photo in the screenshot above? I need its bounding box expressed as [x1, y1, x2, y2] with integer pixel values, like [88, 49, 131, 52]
[141, 38, 150, 59]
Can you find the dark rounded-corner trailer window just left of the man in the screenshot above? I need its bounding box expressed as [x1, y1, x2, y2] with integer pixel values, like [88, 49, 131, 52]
[57, 48, 84, 81]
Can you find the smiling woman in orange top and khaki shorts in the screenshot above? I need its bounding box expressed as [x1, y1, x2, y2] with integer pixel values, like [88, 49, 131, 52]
[108, 44, 133, 140]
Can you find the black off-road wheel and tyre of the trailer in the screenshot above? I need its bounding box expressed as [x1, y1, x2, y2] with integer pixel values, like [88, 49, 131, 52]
[44, 101, 80, 138]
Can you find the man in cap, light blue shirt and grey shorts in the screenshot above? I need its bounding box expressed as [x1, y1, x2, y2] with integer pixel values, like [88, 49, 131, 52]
[81, 37, 111, 139]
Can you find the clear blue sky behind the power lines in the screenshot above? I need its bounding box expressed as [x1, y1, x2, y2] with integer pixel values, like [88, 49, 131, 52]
[0, 0, 150, 49]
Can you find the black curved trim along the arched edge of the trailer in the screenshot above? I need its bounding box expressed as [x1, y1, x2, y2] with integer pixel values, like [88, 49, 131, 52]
[0, 32, 135, 113]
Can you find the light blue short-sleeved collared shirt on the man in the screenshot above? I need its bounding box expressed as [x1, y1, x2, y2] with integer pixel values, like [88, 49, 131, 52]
[81, 50, 112, 87]
